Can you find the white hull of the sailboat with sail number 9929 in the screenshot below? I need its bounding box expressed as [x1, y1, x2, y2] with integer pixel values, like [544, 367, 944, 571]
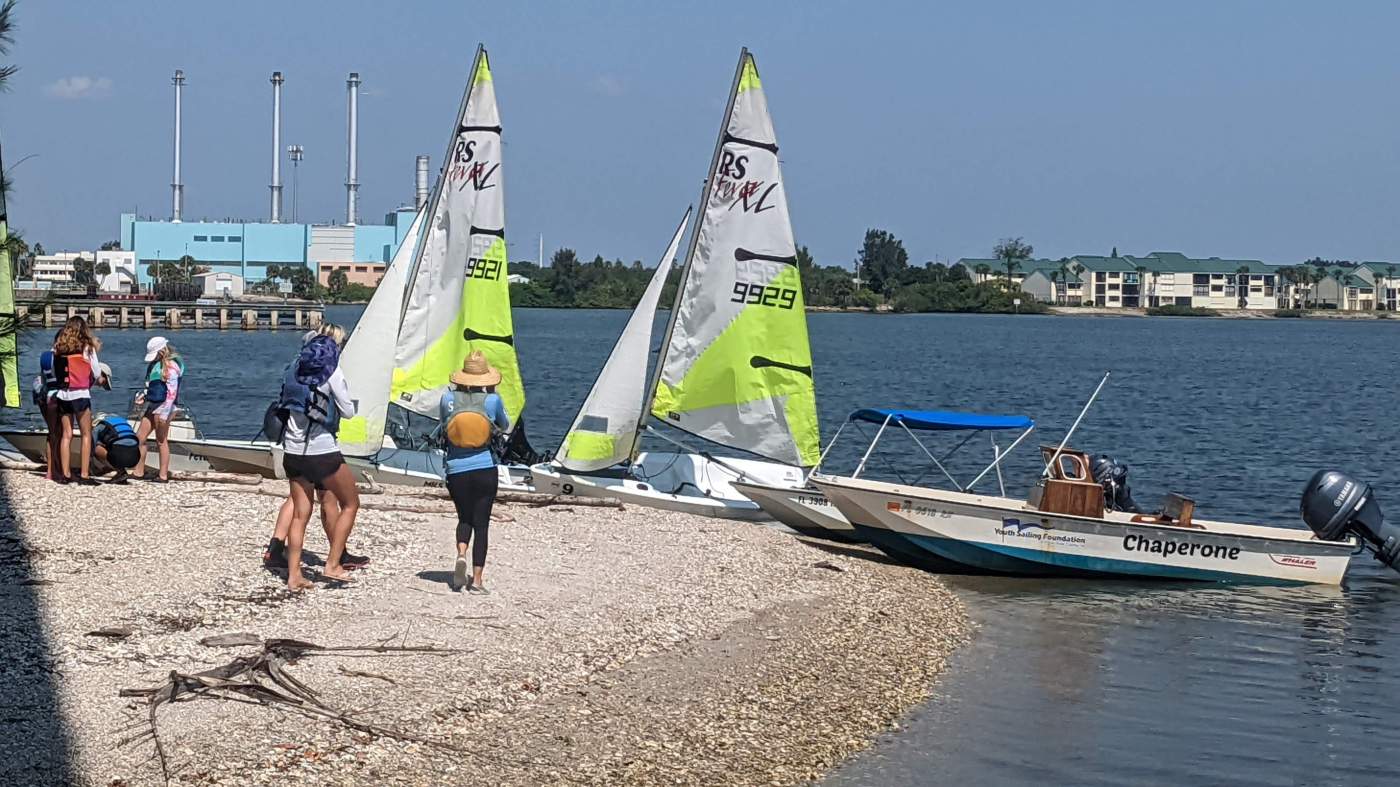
[531, 452, 802, 521]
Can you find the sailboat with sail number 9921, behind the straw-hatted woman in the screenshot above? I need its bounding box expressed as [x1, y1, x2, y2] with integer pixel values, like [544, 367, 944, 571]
[131, 46, 535, 490]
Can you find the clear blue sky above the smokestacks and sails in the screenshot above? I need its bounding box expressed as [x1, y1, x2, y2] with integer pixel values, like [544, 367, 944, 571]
[0, 0, 1400, 265]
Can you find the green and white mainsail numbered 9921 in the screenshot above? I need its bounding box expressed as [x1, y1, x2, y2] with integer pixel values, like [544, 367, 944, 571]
[391, 48, 525, 422]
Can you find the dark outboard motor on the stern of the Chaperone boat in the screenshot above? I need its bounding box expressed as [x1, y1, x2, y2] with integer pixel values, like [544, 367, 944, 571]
[1298, 471, 1400, 571]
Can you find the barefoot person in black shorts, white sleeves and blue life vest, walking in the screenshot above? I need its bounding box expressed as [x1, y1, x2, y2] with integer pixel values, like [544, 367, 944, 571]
[279, 324, 360, 591]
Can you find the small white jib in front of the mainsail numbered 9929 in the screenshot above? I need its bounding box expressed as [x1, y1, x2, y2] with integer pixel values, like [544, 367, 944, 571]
[556, 209, 690, 472]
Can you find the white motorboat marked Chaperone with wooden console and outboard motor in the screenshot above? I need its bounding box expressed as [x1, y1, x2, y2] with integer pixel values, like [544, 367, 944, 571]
[811, 410, 1400, 584]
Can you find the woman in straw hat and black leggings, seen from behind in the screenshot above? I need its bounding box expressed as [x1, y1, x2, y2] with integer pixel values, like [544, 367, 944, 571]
[440, 350, 511, 594]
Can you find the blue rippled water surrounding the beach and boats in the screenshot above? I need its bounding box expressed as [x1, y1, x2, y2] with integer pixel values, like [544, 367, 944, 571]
[2, 308, 1400, 784]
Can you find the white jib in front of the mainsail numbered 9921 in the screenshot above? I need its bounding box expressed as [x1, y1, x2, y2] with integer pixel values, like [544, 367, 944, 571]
[337, 211, 426, 457]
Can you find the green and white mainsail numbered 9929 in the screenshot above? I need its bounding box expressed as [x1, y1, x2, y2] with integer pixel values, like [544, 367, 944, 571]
[651, 50, 820, 466]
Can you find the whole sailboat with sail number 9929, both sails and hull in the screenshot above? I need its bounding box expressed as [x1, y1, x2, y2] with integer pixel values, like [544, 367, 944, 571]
[532, 49, 819, 520]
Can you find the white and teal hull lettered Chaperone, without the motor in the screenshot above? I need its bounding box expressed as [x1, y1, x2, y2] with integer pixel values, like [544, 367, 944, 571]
[812, 476, 1354, 584]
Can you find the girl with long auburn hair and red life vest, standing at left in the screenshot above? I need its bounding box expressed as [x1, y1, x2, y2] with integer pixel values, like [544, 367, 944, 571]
[53, 316, 102, 486]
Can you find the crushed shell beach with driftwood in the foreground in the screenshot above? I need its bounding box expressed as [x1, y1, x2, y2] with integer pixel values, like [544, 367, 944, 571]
[0, 469, 970, 786]
